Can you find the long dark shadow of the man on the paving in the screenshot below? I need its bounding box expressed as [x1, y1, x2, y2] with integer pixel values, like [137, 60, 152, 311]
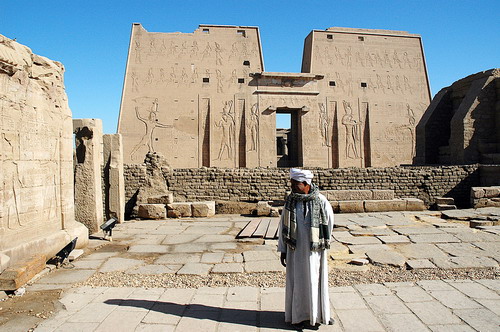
[104, 299, 296, 331]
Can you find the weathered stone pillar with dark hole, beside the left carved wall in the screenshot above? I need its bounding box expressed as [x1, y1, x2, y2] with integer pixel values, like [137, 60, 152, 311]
[73, 119, 104, 234]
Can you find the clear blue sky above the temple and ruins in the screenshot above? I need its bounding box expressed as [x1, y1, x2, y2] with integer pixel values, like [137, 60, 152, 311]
[0, 0, 500, 133]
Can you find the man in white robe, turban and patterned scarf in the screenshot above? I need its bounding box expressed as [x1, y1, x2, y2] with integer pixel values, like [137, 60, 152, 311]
[278, 168, 333, 329]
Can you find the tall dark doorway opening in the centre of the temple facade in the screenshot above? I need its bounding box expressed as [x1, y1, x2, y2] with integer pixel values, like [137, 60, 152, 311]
[276, 108, 302, 167]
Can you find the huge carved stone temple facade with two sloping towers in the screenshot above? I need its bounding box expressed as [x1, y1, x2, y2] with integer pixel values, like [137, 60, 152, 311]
[118, 24, 430, 168]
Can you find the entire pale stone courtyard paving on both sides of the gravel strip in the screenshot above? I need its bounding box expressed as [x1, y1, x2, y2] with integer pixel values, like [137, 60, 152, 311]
[0, 208, 500, 331]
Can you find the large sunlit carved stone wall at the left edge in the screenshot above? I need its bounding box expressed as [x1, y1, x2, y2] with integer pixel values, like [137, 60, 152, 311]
[0, 35, 88, 276]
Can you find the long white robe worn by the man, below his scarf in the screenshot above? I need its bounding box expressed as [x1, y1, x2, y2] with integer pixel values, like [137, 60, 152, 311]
[278, 194, 333, 325]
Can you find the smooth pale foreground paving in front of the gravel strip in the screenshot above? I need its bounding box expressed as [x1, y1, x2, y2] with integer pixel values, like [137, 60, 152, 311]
[31, 280, 500, 332]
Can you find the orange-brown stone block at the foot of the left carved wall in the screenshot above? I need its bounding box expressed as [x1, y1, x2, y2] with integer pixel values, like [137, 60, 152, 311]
[0, 255, 47, 291]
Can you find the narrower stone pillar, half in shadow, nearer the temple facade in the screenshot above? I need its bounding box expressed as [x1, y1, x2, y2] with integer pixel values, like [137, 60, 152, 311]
[103, 134, 125, 223]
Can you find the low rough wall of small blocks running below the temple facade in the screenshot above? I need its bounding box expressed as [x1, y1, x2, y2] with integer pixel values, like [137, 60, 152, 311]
[124, 164, 480, 218]
